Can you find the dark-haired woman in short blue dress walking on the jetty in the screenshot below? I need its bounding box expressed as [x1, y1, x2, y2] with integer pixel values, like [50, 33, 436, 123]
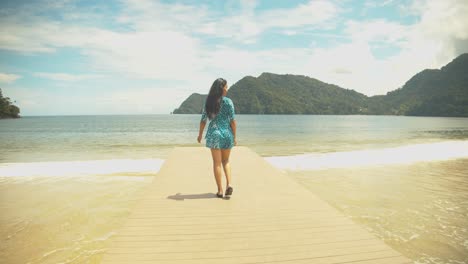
[197, 78, 237, 199]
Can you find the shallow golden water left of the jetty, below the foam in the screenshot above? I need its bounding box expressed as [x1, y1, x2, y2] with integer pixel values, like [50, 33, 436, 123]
[0, 176, 151, 264]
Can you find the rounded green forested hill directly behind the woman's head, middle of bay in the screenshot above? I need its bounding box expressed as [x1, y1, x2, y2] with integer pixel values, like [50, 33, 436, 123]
[173, 73, 367, 114]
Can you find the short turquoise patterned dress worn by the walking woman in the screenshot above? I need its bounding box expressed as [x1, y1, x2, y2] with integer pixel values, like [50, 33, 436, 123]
[201, 96, 235, 149]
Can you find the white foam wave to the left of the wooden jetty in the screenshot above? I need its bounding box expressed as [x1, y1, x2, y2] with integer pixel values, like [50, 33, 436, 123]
[0, 159, 164, 177]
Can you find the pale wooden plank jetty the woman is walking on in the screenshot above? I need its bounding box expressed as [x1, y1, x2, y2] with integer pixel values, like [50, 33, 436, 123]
[101, 147, 412, 264]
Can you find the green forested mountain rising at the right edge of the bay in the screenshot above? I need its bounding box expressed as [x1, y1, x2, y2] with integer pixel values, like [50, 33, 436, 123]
[369, 53, 468, 116]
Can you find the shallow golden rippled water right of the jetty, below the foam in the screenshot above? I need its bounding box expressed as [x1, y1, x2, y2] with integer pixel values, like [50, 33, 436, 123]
[289, 159, 468, 263]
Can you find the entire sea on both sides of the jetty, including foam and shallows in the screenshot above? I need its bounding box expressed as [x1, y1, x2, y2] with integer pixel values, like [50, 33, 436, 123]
[0, 114, 468, 264]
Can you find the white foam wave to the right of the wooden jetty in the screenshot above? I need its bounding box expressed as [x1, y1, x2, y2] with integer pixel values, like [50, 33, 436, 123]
[265, 141, 468, 170]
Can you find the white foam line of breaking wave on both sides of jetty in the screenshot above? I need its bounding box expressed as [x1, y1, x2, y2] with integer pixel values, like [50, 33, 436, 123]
[0, 141, 468, 177]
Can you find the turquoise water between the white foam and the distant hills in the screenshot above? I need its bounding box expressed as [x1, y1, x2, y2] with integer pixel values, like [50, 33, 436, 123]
[0, 115, 468, 163]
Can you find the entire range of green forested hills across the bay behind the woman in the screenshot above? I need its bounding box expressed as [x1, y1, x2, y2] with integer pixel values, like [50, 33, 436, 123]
[173, 53, 468, 117]
